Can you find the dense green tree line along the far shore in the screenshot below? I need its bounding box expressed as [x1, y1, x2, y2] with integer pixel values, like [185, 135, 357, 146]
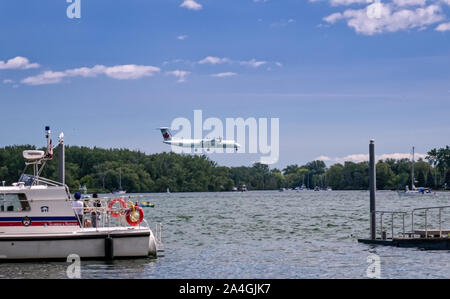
[0, 145, 450, 193]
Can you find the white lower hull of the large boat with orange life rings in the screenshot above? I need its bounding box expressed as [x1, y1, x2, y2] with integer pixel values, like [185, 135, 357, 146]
[0, 229, 157, 261]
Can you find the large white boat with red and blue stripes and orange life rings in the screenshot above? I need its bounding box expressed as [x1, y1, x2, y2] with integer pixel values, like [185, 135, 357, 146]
[0, 129, 157, 261]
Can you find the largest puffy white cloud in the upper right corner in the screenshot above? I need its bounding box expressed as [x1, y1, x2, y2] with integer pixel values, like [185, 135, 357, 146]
[323, 4, 444, 35]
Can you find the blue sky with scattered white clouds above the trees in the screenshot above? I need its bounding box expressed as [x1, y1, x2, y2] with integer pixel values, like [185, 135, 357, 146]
[0, 0, 450, 167]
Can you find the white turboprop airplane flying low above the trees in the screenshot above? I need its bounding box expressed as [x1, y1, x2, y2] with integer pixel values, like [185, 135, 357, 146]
[159, 127, 241, 151]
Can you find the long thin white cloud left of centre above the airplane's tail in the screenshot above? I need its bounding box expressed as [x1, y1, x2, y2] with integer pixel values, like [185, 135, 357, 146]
[21, 64, 160, 85]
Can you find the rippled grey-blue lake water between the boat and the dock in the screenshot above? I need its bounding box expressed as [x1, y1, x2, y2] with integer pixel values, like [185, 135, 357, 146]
[0, 191, 450, 278]
